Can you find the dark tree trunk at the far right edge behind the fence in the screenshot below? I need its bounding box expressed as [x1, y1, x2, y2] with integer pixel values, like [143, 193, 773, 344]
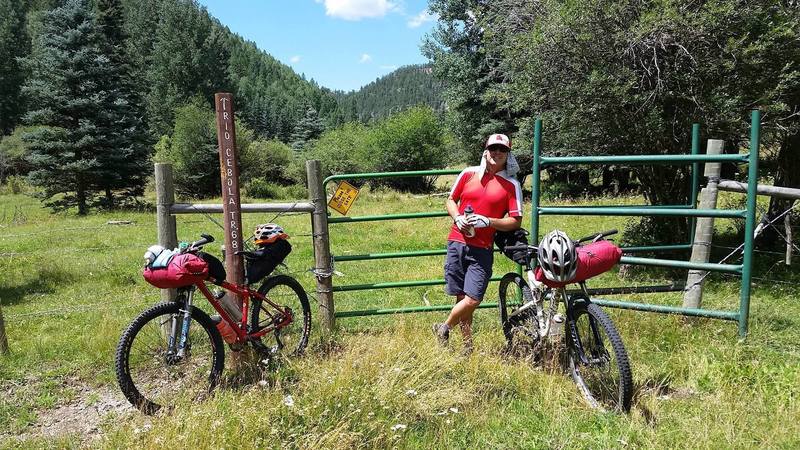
[763, 132, 800, 244]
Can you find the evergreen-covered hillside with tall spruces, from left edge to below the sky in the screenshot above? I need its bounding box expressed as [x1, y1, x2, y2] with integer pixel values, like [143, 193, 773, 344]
[0, 0, 441, 214]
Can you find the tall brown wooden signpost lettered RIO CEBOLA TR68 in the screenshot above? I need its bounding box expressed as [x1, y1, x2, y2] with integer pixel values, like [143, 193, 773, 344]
[214, 93, 244, 320]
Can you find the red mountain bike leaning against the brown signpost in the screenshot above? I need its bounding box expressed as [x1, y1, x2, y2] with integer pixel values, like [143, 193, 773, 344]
[115, 235, 311, 414]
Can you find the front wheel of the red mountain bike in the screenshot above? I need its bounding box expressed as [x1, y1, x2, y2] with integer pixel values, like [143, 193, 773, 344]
[115, 303, 225, 414]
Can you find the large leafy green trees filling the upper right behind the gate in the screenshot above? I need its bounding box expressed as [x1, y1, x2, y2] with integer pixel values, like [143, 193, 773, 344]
[425, 0, 800, 243]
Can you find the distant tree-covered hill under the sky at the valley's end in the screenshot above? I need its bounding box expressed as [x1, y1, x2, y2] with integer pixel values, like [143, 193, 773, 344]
[337, 65, 444, 122]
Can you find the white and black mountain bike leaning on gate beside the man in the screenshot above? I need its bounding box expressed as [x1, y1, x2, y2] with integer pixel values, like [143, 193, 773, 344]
[498, 230, 633, 412]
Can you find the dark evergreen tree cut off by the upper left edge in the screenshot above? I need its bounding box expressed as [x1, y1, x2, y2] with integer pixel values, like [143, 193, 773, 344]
[0, 0, 29, 135]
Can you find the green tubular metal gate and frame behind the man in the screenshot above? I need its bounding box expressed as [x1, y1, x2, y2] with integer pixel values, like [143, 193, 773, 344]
[324, 110, 760, 337]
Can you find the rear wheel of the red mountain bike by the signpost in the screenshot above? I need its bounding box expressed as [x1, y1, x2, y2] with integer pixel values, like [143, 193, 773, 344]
[250, 275, 311, 356]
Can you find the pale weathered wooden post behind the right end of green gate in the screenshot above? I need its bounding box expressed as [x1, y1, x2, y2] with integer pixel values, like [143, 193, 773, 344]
[683, 139, 725, 308]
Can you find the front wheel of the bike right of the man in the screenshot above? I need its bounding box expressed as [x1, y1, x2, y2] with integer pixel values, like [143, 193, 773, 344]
[568, 300, 633, 412]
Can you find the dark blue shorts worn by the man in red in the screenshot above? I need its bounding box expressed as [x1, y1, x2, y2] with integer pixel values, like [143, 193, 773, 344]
[444, 241, 494, 301]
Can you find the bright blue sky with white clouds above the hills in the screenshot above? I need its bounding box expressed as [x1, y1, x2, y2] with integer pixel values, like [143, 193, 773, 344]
[199, 0, 435, 91]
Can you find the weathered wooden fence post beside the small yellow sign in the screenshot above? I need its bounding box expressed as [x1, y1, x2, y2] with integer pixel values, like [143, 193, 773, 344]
[306, 161, 336, 336]
